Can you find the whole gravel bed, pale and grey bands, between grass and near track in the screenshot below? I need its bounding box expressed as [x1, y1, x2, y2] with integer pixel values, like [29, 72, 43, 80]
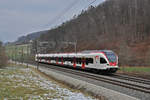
[13, 61, 150, 100]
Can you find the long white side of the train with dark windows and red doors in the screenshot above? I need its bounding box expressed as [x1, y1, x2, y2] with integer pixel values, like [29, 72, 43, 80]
[35, 53, 118, 72]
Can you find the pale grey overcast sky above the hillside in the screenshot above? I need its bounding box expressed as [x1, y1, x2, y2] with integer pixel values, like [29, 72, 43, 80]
[0, 0, 104, 42]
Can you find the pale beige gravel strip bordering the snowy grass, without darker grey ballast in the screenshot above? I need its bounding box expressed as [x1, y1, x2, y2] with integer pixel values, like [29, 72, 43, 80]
[27, 65, 139, 100]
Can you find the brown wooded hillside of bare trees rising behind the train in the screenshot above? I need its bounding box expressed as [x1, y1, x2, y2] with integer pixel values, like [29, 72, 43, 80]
[37, 0, 150, 66]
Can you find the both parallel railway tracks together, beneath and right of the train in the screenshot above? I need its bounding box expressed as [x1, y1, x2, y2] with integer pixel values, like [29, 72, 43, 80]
[24, 62, 150, 94]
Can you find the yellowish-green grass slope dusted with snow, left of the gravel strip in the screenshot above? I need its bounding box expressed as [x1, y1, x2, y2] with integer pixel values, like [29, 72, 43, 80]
[0, 64, 98, 100]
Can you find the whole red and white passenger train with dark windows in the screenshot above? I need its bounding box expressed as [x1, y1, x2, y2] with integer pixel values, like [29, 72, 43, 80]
[35, 50, 118, 73]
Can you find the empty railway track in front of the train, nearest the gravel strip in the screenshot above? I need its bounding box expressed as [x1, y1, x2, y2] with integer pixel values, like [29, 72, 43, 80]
[37, 64, 150, 94]
